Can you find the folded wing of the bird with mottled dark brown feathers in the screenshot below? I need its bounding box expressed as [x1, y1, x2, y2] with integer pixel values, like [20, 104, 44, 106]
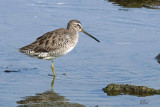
[20, 29, 69, 53]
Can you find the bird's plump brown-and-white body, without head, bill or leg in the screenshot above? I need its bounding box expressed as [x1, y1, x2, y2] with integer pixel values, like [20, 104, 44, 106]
[19, 28, 78, 59]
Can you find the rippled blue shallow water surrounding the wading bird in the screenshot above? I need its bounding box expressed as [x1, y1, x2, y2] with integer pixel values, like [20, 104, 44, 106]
[0, 0, 160, 107]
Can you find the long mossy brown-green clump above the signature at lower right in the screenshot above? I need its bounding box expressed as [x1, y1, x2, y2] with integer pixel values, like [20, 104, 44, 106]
[103, 84, 160, 97]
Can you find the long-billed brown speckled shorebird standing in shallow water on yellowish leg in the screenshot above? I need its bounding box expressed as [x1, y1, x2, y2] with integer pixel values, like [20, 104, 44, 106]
[19, 19, 100, 77]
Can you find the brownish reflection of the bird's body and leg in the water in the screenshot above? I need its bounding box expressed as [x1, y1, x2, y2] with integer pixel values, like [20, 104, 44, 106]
[17, 77, 85, 107]
